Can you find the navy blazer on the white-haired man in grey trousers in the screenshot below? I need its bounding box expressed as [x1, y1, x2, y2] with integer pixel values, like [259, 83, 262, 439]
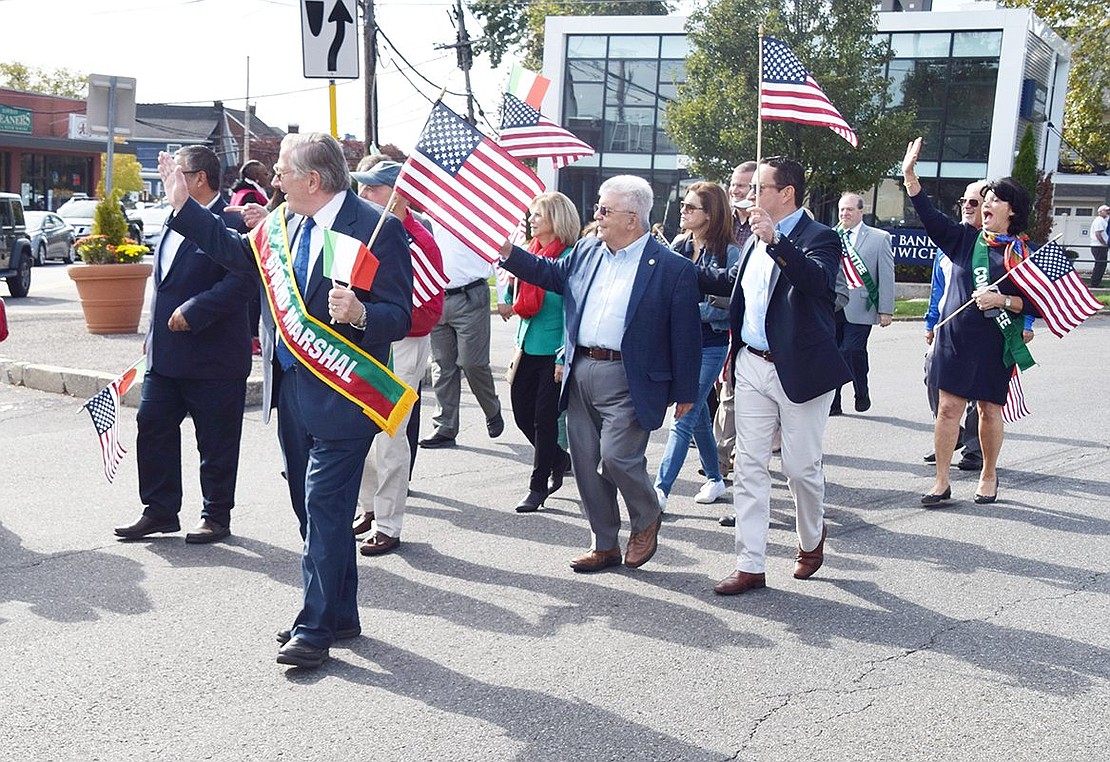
[502, 237, 702, 431]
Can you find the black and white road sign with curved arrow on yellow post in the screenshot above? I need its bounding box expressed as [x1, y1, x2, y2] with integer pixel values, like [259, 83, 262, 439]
[301, 0, 359, 79]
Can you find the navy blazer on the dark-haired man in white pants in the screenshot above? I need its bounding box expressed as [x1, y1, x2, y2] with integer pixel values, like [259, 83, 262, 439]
[698, 214, 851, 403]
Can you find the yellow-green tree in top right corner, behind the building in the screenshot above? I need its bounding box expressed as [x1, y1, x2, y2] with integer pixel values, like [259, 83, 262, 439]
[1002, 0, 1110, 170]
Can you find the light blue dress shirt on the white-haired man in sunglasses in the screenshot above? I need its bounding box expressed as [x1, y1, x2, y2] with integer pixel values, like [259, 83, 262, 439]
[575, 233, 648, 351]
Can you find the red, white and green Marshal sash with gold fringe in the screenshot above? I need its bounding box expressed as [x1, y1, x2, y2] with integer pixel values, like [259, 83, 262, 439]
[250, 204, 416, 437]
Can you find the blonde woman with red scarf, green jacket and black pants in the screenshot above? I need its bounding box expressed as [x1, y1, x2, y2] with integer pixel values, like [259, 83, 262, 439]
[509, 193, 582, 513]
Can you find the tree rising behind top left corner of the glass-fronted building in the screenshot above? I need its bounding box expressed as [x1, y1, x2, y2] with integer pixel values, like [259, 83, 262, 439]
[467, 0, 670, 71]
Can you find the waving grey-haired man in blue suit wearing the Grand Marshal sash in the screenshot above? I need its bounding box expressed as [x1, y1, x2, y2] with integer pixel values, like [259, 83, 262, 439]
[159, 133, 413, 669]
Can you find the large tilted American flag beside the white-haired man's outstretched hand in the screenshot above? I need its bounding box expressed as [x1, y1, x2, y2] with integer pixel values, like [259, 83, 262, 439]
[395, 103, 544, 262]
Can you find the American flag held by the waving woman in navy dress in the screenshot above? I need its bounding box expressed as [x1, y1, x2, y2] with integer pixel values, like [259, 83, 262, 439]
[1010, 241, 1102, 337]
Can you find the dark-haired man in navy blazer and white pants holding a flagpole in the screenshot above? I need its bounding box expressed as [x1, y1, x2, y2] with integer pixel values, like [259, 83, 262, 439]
[698, 157, 851, 595]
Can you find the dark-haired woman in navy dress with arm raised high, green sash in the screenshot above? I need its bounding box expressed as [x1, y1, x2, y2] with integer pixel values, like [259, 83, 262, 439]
[902, 138, 1040, 505]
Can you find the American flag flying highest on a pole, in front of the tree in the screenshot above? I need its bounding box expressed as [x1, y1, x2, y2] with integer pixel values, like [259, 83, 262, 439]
[759, 37, 859, 148]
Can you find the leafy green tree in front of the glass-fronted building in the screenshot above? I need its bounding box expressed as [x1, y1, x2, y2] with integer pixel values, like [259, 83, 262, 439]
[667, 0, 914, 212]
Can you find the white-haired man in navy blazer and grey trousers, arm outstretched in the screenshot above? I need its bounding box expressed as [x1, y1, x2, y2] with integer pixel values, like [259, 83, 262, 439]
[501, 176, 702, 572]
